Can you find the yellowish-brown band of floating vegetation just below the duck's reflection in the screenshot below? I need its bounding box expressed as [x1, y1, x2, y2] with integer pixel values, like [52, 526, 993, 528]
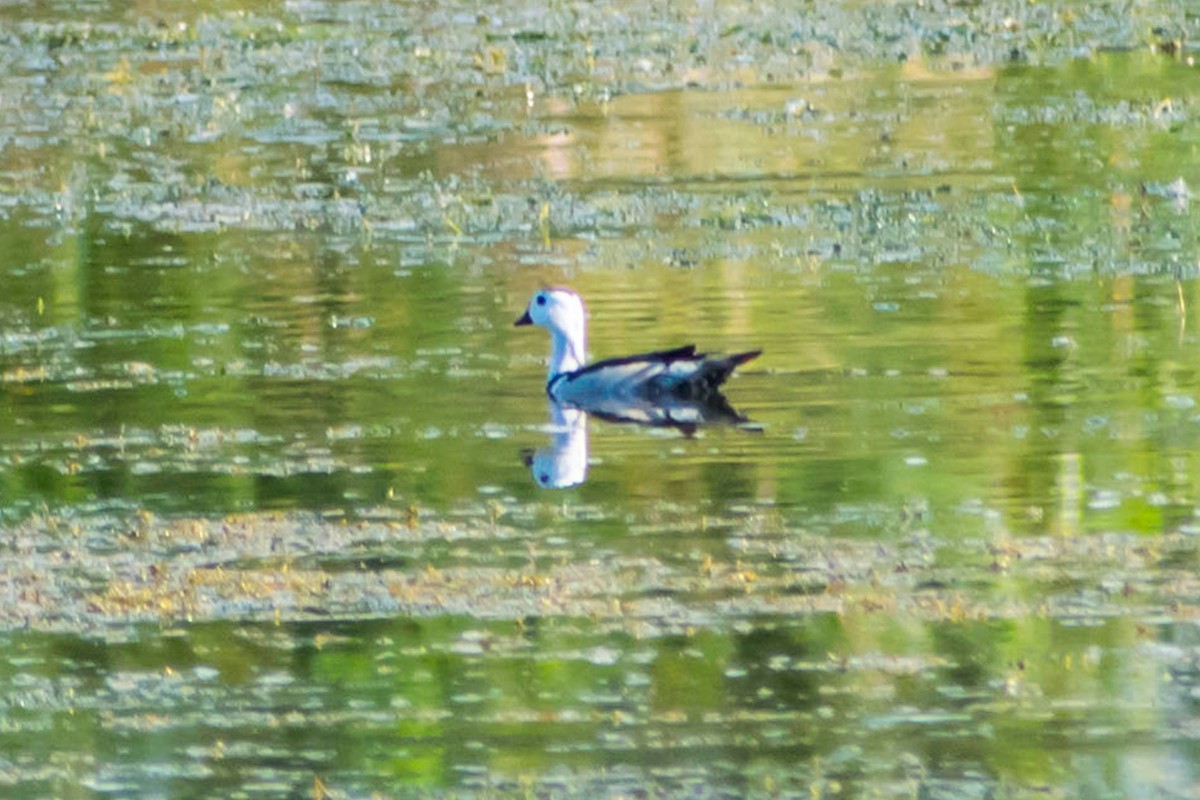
[0, 511, 1200, 636]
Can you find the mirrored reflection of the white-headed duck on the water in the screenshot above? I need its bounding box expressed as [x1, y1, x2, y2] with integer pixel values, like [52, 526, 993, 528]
[522, 392, 749, 489]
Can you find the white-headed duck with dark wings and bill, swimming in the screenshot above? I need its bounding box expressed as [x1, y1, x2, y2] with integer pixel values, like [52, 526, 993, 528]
[514, 287, 762, 409]
